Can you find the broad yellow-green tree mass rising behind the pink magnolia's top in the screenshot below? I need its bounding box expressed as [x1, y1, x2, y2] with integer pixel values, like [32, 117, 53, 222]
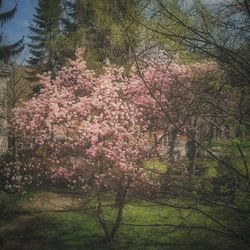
[64, 0, 144, 67]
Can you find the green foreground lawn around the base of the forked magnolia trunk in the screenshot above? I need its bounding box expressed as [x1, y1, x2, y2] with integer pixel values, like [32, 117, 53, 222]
[0, 197, 247, 250]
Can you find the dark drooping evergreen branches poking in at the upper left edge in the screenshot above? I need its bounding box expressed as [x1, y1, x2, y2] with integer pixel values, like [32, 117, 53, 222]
[0, 0, 24, 62]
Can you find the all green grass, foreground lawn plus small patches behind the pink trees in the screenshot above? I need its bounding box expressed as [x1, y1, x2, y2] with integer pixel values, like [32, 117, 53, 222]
[0, 153, 250, 250]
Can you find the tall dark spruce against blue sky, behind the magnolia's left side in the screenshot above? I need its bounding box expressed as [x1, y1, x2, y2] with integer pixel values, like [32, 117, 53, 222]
[28, 0, 63, 76]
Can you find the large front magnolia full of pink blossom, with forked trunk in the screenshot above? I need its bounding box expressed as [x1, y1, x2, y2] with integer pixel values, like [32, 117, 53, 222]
[13, 50, 152, 240]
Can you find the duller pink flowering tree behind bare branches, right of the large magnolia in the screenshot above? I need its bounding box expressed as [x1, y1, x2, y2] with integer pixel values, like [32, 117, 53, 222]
[127, 56, 226, 177]
